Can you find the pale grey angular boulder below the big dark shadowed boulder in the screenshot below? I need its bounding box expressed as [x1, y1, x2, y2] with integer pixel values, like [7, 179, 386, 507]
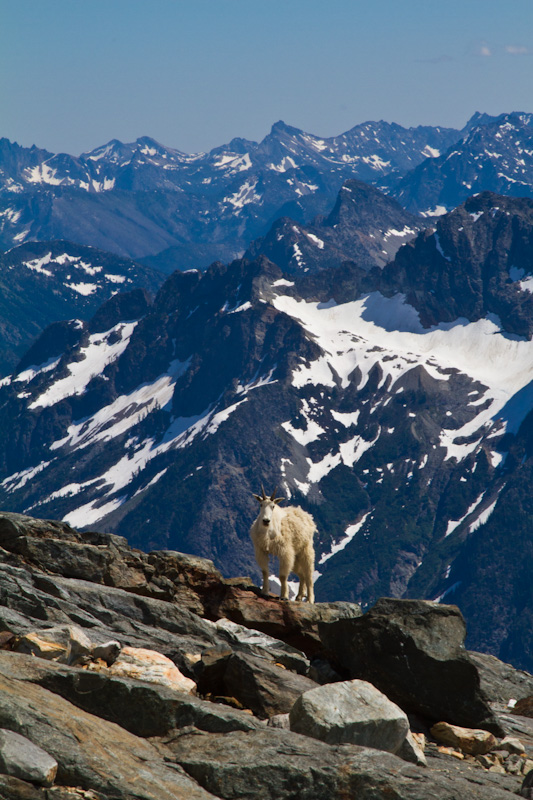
[289, 680, 409, 753]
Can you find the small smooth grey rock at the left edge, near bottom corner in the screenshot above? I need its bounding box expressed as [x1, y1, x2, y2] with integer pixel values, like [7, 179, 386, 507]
[0, 728, 57, 786]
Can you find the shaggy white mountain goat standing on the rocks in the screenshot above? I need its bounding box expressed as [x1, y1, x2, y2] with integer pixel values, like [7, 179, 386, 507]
[250, 486, 316, 603]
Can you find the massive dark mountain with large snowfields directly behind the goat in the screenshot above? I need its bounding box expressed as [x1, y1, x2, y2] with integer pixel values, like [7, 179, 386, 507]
[0, 192, 533, 670]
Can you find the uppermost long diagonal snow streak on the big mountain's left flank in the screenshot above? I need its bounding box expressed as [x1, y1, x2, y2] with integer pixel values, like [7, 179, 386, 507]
[28, 322, 137, 409]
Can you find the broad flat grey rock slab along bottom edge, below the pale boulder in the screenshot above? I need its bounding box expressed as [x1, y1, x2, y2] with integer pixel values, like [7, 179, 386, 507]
[164, 728, 513, 800]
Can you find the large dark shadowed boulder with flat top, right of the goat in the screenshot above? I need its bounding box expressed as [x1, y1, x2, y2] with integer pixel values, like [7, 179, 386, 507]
[320, 598, 503, 736]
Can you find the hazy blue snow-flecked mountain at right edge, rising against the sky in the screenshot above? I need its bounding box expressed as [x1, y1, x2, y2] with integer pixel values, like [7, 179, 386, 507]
[382, 113, 533, 215]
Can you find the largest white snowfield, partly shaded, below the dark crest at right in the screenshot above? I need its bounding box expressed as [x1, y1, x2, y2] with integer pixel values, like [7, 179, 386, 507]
[272, 292, 533, 450]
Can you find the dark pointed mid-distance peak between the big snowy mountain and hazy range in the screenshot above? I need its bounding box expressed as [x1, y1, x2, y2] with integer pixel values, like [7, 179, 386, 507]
[245, 180, 423, 275]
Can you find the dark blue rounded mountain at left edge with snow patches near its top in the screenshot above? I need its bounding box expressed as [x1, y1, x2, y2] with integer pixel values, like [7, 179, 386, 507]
[0, 241, 163, 376]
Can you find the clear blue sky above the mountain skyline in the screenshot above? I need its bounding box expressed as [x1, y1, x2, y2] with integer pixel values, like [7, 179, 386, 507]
[0, 0, 533, 155]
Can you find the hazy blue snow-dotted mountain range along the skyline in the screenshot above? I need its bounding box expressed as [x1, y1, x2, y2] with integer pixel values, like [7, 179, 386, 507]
[4, 112, 533, 273]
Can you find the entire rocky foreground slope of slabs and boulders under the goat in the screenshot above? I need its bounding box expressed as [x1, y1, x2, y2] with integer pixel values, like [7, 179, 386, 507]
[0, 513, 533, 800]
